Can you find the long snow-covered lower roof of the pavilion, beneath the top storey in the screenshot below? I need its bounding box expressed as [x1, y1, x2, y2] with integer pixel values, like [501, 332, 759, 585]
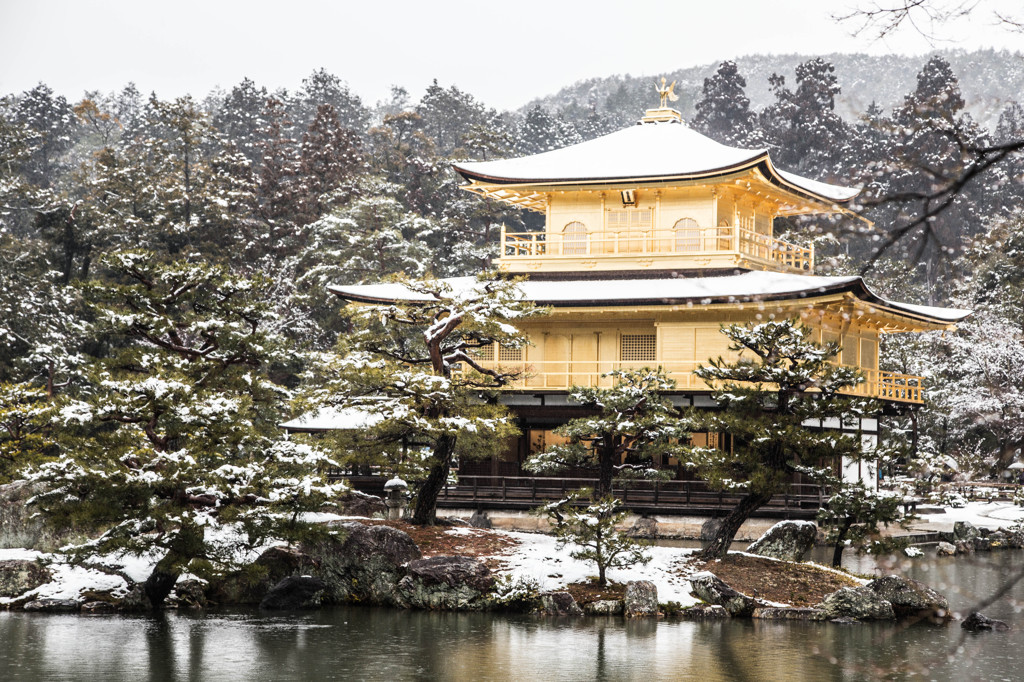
[329, 271, 971, 324]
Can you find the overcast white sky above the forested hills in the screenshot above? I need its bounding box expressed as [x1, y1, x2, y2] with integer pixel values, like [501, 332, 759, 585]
[0, 0, 1024, 109]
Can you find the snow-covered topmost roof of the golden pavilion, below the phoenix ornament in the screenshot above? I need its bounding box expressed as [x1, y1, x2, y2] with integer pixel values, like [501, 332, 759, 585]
[454, 122, 859, 203]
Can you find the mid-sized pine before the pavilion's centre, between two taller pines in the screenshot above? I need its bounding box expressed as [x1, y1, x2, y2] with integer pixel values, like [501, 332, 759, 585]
[523, 369, 689, 499]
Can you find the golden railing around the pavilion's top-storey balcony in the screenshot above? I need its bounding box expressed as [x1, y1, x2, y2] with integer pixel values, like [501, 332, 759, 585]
[501, 225, 814, 272]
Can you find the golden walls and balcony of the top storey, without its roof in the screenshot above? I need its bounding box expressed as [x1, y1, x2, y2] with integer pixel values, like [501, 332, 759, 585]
[497, 183, 814, 272]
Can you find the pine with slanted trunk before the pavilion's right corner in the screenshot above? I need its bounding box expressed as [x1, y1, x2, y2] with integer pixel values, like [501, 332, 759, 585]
[684, 321, 877, 559]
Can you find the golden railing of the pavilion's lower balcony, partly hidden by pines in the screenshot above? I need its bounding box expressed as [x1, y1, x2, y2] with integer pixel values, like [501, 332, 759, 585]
[466, 360, 924, 403]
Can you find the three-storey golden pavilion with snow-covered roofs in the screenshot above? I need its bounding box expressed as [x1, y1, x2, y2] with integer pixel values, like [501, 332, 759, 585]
[332, 100, 969, 503]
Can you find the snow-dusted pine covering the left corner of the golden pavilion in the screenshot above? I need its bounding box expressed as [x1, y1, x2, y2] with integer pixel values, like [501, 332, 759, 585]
[314, 276, 541, 524]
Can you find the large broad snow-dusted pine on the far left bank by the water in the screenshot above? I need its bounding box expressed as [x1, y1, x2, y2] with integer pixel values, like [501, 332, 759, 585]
[30, 252, 339, 607]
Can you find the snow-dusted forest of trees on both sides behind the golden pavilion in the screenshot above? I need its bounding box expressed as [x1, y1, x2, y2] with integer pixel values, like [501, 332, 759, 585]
[0, 49, 1024, 503]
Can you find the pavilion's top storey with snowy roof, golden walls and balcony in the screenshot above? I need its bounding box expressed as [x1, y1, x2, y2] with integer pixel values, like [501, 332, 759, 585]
[455, 110, 857, 273]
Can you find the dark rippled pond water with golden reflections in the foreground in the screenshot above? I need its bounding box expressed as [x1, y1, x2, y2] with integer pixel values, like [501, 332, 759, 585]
[0, 550, 1024, 682]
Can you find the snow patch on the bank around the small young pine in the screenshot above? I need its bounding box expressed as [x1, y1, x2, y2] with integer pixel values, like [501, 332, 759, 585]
[496, 532, 697, 606]
